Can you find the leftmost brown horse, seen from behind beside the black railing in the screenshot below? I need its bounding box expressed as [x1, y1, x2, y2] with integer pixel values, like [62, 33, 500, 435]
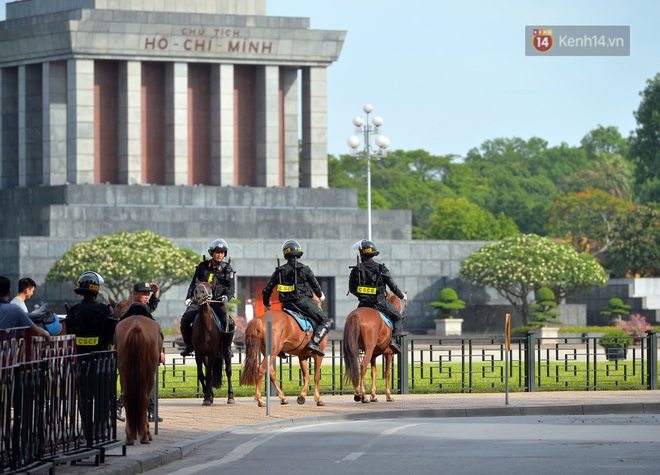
[115, 315, 163, 445]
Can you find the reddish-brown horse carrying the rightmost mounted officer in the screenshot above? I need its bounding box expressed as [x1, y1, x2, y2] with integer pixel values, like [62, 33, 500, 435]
[343, 294, 405, 402]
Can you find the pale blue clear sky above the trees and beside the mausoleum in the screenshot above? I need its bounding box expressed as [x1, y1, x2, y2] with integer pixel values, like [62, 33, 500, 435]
[0, 0, 660, 157]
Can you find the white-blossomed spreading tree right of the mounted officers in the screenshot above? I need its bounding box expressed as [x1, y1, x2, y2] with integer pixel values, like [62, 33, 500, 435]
[459, 234, 607, 325]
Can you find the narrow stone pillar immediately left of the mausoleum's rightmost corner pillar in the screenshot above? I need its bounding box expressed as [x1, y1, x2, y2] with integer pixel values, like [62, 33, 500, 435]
[280, 68, 300, 188]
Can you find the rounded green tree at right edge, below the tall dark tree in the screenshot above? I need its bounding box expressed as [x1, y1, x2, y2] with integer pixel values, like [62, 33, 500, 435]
[605, 206, 660, 277]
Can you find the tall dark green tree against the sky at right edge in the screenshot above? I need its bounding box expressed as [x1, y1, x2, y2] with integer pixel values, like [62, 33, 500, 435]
[630, 73, 660, 202]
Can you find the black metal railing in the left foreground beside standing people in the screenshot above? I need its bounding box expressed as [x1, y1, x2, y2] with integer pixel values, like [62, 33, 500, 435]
[0, 329, 125, 474]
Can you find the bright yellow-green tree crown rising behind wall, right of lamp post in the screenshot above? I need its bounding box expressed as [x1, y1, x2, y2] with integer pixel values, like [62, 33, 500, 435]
[429, 198, 520, 241]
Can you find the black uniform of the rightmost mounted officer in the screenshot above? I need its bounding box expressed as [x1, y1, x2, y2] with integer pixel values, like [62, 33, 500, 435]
[348, 258, 404, 338]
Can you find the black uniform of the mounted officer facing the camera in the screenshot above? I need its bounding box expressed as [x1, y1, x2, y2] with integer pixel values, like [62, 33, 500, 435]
[181, 260, 236, 356]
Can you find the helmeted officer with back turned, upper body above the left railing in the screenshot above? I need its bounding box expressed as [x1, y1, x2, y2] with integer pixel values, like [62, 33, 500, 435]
[66, 271, 117, 353]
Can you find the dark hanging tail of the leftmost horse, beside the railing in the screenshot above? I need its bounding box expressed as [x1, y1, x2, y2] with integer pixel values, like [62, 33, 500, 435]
[122, 321, 157, 432]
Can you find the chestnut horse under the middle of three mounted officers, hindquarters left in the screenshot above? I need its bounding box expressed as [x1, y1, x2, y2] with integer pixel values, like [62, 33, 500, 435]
[241, 297, 328, 407]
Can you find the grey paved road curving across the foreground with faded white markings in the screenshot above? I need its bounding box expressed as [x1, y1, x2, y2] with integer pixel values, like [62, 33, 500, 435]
[146, 415, 660, 475]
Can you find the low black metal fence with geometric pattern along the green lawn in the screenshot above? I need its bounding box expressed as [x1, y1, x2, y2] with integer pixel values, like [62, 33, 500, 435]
[159, 331, 658, 397]
